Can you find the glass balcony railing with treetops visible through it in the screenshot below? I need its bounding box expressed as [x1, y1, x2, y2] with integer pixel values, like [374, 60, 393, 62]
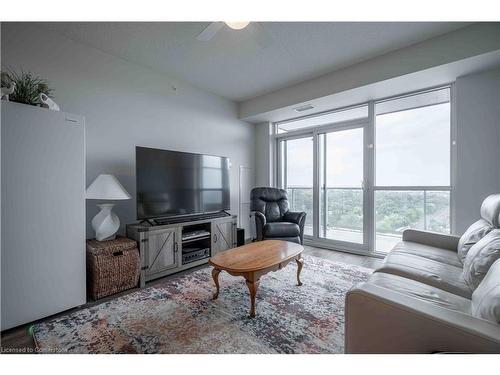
[286, 186, 450, 251]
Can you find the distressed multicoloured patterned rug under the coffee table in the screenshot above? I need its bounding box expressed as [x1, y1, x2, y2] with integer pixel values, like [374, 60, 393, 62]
[33, 256, 371, 353]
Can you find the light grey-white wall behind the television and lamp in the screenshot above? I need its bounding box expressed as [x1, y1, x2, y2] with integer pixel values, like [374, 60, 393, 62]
[1, 23, 255, 237]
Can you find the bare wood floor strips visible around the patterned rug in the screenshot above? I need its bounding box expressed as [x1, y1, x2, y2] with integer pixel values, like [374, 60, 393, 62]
[0, 246, 382, 353]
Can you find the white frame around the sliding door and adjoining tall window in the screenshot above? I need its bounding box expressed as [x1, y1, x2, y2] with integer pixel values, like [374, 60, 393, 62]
[271, 82, 457, 258]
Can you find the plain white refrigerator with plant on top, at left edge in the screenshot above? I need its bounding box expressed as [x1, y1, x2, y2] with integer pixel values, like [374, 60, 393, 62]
[0, 101, 86, 331]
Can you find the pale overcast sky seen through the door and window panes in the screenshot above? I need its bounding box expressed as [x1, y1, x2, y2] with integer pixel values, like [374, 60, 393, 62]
[287, 103, 450, 187]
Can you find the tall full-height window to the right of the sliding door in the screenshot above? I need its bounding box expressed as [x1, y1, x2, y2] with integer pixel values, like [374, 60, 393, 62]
[375, 88, 451, 252]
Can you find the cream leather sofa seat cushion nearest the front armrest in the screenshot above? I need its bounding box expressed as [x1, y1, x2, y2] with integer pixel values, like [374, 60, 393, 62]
[375, 252, 472, 299]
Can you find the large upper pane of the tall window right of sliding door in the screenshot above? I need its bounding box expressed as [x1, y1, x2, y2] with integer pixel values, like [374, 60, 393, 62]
[375, 94, 450, 186]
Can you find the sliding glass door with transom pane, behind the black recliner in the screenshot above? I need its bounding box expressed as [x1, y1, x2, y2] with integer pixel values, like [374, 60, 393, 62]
[277, 106, 369, 250]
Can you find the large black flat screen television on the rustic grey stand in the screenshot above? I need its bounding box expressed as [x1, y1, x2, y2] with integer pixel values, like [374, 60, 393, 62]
[135, 147, 230, 220]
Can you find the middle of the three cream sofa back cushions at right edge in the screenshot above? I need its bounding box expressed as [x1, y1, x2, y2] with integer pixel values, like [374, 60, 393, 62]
[463, 229, 500, 289]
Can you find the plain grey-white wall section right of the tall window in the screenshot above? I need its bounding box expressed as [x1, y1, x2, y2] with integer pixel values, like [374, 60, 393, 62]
[455, 69, 500, 233]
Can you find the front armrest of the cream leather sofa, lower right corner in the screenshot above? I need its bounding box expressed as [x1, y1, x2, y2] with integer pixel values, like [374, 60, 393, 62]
[345, 282, 500, 353]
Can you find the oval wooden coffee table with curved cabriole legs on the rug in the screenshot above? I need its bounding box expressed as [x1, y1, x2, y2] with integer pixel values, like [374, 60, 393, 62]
[208, 240, 304, 318]
